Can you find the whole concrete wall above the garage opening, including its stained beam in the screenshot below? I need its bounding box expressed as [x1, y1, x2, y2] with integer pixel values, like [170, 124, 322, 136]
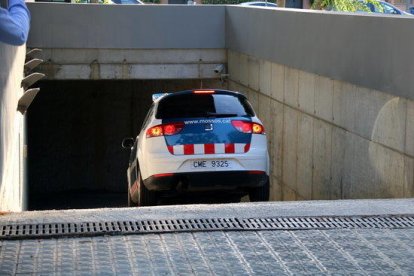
[28, 3, 226, 80]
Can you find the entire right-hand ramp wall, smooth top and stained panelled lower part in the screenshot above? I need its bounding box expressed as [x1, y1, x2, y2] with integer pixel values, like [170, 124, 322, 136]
[226, 7, 414, 200]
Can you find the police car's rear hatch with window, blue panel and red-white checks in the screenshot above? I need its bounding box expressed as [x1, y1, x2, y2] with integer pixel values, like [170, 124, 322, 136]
[156, 91, 254, 155]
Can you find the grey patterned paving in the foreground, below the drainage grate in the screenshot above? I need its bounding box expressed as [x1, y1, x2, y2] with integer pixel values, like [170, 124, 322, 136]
[0, 229, 414, 275]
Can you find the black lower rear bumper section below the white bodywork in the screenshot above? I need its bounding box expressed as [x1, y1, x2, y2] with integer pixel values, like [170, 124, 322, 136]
[144, 171, 269, 192]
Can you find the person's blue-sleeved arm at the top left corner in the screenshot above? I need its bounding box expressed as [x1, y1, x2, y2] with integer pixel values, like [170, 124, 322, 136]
[0, 0, 30, 46]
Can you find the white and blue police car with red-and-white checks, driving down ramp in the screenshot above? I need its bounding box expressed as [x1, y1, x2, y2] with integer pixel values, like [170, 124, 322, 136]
[123, 90, 269, 206]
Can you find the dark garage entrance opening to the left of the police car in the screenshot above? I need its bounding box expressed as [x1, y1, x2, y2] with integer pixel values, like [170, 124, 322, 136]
[27, 80, 225, 210]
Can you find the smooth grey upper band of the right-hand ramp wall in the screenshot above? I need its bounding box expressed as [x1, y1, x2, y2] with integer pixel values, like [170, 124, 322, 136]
[226, 6, 414, 100]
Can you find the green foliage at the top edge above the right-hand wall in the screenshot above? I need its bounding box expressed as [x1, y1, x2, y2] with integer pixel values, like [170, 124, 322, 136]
[312, 0, 382, 12]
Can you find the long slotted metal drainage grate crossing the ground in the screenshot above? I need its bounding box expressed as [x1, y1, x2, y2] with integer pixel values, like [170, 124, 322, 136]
[0, 215, 414, 239]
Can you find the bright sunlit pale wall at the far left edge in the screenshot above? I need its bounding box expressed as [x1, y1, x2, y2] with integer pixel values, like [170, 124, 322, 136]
[0, 43, 25, 211]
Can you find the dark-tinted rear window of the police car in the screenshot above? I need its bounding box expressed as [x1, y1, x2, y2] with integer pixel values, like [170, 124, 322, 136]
[155, 94, 254, 119]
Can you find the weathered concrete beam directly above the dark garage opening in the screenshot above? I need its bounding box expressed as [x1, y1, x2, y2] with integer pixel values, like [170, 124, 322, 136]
[36, 49, 227, 80]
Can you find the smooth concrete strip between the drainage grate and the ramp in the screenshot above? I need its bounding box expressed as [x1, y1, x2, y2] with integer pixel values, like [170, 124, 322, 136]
[0, 199, 414, 224]
